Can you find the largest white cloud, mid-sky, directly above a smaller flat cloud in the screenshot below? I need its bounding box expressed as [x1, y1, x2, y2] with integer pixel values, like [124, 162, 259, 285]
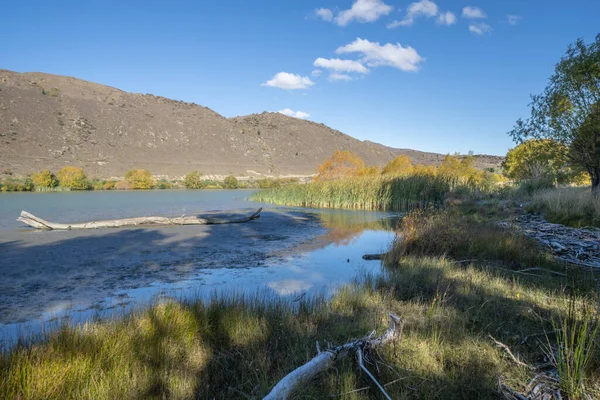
[335, 38, 424, 71]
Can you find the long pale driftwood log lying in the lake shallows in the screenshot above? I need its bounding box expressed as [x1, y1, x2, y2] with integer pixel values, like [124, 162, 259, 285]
[17, 208, 262, 230]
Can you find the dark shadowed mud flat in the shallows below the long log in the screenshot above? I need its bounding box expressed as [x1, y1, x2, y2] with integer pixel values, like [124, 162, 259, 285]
[0, 210, 324, 324]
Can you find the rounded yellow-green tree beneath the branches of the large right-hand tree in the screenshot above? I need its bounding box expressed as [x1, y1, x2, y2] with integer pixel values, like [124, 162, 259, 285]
[502, 139, 574, 184]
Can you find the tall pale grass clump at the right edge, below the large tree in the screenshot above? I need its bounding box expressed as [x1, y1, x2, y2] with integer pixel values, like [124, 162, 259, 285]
[530, 187, 600, 228]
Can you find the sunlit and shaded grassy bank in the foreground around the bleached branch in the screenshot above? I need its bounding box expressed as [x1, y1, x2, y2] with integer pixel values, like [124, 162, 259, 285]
[0, 205, 600, 399]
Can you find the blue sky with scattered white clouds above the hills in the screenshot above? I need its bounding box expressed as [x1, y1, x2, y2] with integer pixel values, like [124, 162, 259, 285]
[0, 0, 600, 155]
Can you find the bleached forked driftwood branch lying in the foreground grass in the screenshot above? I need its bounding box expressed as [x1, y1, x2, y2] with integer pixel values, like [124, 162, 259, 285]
[263, 314, 403, 400]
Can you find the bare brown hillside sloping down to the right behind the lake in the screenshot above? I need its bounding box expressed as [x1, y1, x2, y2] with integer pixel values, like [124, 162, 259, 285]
[0, 70, 502, 177]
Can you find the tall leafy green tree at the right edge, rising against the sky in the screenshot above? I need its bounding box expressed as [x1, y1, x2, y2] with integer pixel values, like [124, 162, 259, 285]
[509, 34, 600, 193]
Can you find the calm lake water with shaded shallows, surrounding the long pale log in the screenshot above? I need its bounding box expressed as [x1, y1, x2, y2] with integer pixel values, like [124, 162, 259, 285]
[0, 190, 399, 348]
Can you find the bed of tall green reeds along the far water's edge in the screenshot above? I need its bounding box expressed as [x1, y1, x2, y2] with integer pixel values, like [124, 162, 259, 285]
[251, 174, 450, 210]
